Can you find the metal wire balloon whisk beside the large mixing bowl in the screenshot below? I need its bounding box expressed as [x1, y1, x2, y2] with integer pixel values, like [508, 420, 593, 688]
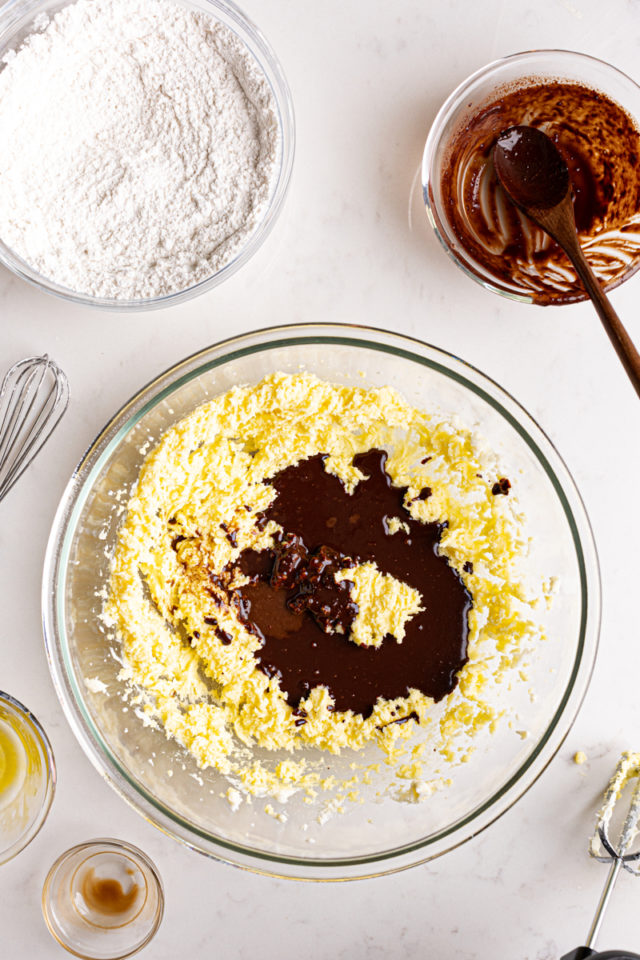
[0, 354, 69, 500]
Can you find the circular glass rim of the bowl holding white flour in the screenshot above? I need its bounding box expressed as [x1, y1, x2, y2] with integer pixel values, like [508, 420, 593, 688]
[0, 0, 296, 313]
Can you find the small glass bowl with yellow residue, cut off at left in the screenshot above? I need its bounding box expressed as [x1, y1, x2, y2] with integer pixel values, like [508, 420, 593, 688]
[0, 691, 56, 864]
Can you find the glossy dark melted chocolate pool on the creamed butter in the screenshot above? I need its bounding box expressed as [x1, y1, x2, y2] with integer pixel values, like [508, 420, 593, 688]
[229, 450, 471, 712]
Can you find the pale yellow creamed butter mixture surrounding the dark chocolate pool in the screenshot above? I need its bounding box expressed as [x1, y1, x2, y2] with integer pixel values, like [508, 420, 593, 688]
[105, 373, 538, 798]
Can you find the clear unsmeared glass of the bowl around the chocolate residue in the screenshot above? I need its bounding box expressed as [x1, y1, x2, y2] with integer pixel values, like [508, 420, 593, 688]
[422, 50, 640, 303]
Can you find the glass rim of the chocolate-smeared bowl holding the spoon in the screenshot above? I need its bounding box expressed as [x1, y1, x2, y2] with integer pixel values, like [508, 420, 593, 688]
[420, 47, 640, 306]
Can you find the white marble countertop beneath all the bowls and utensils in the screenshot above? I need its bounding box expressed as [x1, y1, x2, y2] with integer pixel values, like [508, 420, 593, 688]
[0, 0, 640, 960]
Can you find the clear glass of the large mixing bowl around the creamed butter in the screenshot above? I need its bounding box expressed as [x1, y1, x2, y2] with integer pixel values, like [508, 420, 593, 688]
[43, 324, 600, 880]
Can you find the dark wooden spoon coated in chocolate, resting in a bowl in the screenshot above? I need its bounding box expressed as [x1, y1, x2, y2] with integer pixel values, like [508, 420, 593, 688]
[493, 126, 640, 396]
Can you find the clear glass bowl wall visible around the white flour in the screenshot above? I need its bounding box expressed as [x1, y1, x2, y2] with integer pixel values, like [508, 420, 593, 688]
[0, 0, 295, 311]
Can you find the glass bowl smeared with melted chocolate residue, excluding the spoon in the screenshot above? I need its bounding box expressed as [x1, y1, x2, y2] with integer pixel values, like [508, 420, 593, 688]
[422, 50, 640, 305]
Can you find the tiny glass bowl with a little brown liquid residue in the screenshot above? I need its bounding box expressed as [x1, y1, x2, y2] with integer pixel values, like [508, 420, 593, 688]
[42, 839, 164, 960]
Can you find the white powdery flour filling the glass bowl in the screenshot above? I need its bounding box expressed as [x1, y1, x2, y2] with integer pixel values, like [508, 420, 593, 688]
[0, 0, 280, 299]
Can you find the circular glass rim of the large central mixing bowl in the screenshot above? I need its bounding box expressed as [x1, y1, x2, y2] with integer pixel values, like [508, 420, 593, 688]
[42, 323, 601, 880]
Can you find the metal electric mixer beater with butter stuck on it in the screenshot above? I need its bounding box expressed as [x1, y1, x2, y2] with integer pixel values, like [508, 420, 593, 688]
[562, 753, 640, 960]
